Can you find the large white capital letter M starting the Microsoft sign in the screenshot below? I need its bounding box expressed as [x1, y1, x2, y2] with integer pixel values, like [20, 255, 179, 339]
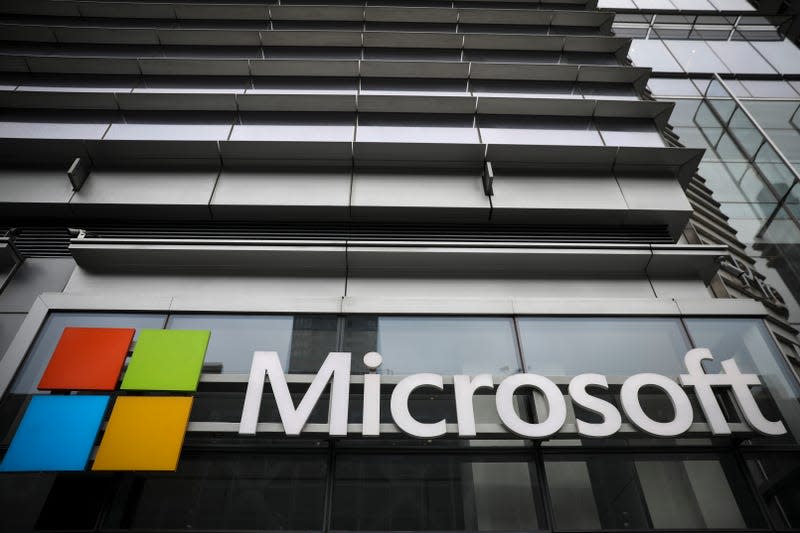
[239, 352, 350, 437]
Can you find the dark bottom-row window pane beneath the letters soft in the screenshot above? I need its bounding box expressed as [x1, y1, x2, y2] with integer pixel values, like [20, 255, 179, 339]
[545, 454, 763, 530]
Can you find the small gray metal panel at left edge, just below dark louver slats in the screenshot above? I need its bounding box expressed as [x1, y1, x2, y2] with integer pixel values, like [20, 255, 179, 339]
[0, 257, 75, 313]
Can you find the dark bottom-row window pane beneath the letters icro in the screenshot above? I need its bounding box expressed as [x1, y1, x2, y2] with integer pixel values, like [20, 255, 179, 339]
[331, 454, 541, 531]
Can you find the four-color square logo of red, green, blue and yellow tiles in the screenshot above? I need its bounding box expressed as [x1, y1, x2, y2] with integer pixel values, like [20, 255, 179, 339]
[0, 328, 211, 472]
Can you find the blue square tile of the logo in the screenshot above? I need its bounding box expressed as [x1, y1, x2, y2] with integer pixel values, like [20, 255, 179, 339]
[0, 396, 109, 472]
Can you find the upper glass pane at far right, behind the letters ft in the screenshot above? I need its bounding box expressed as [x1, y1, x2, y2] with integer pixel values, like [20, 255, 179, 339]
[686, 318, 800, 443]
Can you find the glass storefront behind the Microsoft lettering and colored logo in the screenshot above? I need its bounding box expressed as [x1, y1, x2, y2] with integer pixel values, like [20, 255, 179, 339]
[0, 312, 800, 531]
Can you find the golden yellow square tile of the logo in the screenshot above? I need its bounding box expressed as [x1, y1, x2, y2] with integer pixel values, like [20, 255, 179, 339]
[92, 396, 192, 470]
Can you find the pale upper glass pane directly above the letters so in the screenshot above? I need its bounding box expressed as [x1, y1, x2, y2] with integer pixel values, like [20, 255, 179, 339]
[518, 317, 691, 376]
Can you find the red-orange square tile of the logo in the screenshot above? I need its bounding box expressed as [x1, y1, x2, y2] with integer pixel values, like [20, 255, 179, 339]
[39, 328, 135, 390]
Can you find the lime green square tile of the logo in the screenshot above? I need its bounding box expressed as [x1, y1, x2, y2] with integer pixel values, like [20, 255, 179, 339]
[122, 329, 211, 391]
